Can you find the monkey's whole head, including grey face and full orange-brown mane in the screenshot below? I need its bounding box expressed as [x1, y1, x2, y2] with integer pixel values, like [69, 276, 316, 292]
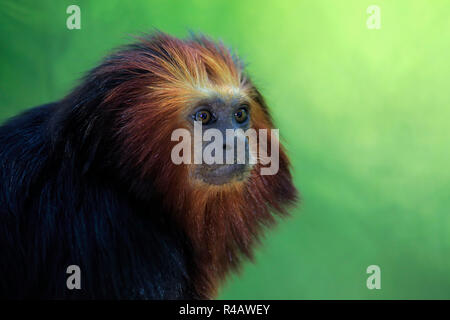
[60, 33, 297, 297]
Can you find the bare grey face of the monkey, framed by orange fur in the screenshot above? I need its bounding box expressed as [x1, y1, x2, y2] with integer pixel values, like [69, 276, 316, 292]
[188, 95, 252, 185]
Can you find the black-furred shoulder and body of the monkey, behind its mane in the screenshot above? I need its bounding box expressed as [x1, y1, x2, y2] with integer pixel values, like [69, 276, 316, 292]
[0, 104, 197, 299]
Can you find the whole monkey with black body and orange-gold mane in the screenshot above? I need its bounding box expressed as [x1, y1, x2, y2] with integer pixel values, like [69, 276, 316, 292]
[0, 31, 299, 300]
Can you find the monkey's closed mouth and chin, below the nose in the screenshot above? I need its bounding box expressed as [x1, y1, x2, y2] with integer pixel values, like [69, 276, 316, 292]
[196, 164, 249, 185]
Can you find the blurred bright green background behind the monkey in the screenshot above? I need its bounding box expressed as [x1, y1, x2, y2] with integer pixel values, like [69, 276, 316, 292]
[0, 0, 450, 299]
